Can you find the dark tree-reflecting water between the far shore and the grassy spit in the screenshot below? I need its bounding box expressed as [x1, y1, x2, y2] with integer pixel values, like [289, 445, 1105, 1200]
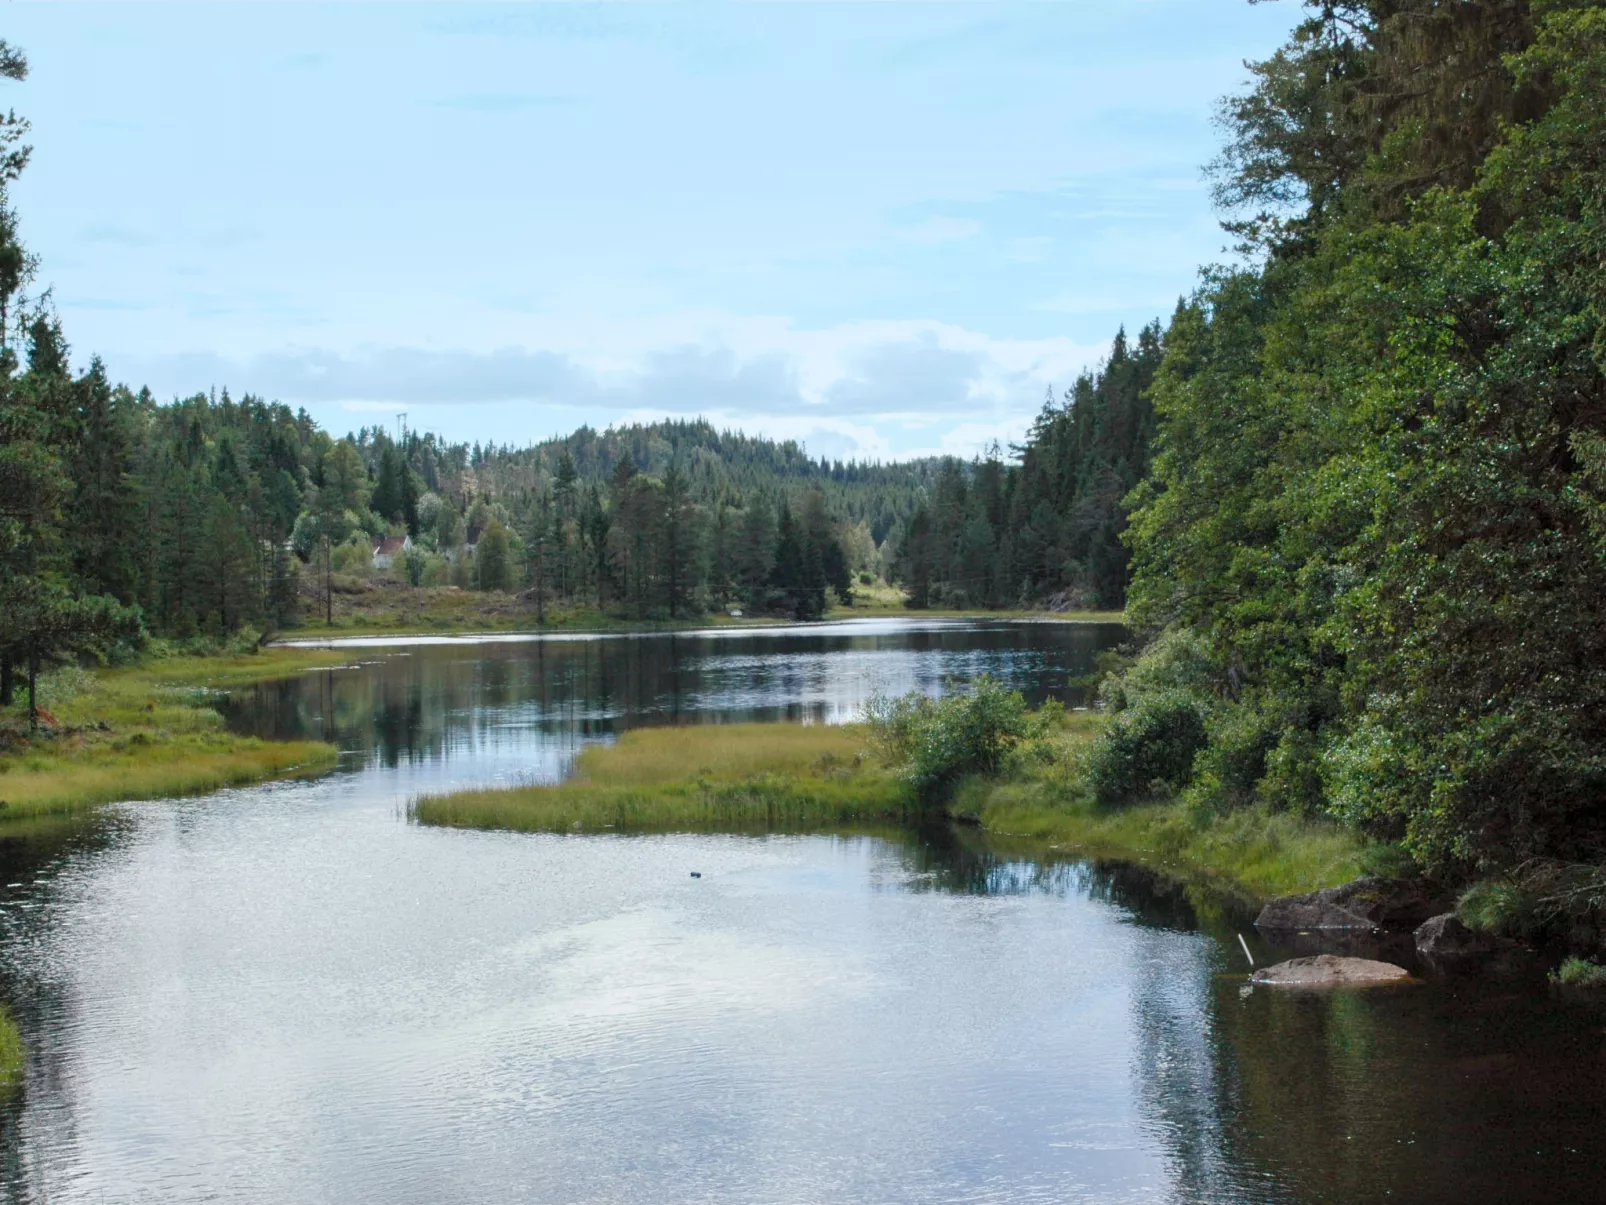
[225, 625, 1121, 766]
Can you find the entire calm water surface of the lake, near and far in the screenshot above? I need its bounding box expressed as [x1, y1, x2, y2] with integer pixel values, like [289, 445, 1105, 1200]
[0, 622, 1606, 1205]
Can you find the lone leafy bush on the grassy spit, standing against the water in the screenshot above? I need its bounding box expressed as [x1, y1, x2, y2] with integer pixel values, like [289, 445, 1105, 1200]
[864, 676, 1029, 800]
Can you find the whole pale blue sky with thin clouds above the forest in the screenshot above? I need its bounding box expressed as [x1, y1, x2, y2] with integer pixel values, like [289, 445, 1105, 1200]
[0, 0, 1299, 461]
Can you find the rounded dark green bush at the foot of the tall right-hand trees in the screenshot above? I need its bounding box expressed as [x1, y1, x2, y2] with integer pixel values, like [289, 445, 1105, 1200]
[1087, 688, 1208, 805]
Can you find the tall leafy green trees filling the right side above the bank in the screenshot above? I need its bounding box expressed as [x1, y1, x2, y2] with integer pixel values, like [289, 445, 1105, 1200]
[1095, 0, 1606, 879]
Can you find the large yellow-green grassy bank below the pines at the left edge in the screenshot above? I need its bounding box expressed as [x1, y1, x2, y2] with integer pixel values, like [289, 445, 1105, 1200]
[0, 649, 345, 821]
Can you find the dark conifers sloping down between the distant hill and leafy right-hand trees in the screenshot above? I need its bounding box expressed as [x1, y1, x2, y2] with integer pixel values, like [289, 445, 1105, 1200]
[896, 323, 1164, 611]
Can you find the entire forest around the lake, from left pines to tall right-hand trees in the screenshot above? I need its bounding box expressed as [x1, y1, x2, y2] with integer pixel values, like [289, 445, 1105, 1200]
[0, 0, 1606, 874]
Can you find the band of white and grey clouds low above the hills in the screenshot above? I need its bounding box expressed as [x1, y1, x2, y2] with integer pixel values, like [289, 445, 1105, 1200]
[117, 323, 1102, 460]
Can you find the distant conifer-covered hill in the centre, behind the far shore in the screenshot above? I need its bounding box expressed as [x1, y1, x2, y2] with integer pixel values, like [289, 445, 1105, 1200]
[321, 421, 935, 622]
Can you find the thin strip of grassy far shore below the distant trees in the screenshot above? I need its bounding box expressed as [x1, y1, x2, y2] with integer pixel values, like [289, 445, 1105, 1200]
[283, 575, 1123, 641]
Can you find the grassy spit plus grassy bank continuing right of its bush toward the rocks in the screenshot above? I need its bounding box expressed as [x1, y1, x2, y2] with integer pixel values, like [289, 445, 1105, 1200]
[410, 712, 1365, 900]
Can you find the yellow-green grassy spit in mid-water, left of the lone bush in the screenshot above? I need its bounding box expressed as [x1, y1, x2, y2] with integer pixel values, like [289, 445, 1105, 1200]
[410, 723, 909, 832]
